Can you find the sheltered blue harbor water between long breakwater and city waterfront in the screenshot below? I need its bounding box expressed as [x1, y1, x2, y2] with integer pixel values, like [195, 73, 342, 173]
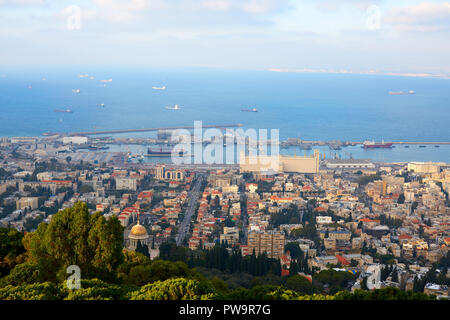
[48, 130, 450, 163]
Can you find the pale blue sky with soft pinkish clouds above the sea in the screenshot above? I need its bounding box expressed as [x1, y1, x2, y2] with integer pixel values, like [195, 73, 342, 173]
[0, 0, 450, 75]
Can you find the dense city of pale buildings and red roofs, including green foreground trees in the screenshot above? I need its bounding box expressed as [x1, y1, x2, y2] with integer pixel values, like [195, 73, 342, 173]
[0, 137, 450, 299]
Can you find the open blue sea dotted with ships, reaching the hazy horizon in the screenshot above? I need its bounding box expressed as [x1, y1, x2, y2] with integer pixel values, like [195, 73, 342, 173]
[0, 68, 450, 162]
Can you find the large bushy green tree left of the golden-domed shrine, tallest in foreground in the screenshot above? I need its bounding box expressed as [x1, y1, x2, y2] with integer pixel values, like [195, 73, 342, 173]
[24, 202, 123, 281]
